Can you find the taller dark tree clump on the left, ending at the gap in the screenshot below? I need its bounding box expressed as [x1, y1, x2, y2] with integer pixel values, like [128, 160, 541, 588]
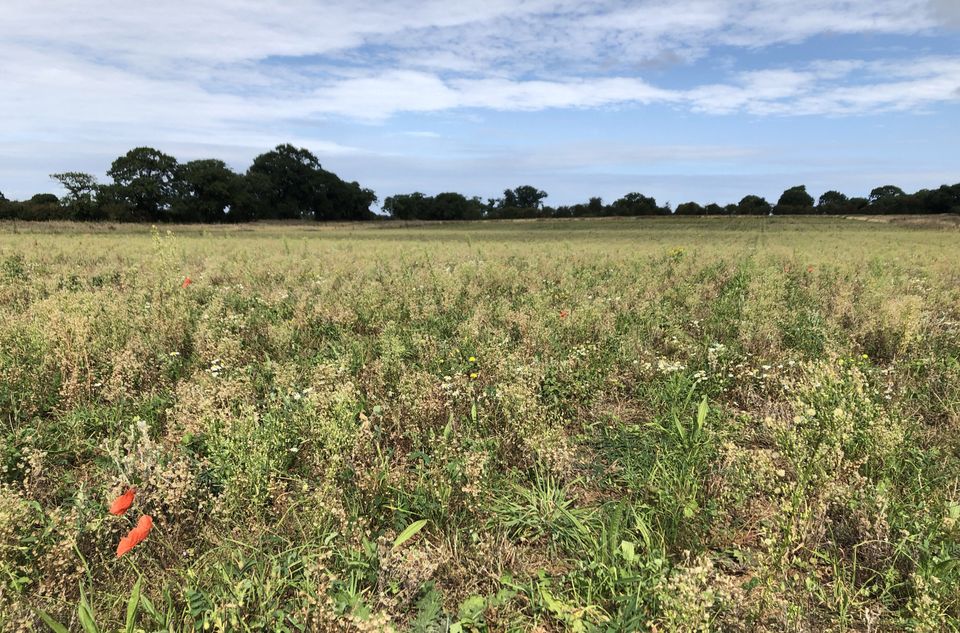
[0, 145, 377, 223]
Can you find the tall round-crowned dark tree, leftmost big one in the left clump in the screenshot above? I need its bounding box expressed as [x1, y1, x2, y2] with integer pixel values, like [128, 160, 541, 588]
[104, 147, 178, 221]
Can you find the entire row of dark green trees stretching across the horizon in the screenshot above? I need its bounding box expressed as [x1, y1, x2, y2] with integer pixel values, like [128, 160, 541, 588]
[0, 144, 960, 223]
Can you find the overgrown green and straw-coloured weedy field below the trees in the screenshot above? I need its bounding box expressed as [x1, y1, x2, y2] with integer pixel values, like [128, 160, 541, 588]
[0, 218, 960, 633]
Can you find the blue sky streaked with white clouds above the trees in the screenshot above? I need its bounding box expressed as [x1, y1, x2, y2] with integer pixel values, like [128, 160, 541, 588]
[0, 0, 960, 206]
